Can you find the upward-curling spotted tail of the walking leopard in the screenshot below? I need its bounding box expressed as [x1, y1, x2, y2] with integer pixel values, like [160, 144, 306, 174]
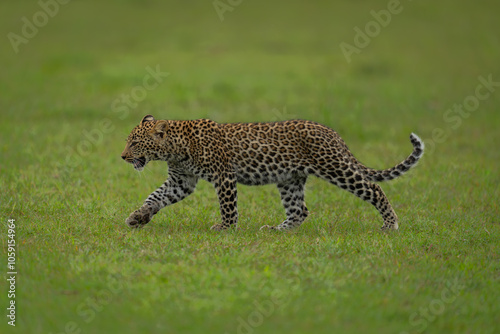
[361, 133, 424, 182]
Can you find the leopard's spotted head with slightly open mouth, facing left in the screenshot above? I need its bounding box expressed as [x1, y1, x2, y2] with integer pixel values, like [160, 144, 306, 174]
[122, 115, 167, 171]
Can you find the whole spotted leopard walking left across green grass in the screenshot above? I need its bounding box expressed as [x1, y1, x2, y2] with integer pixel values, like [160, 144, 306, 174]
[121, 115, 424, 231]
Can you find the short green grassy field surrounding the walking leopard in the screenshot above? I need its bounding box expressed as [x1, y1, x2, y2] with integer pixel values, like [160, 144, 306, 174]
[0, 0, 500, 334]
